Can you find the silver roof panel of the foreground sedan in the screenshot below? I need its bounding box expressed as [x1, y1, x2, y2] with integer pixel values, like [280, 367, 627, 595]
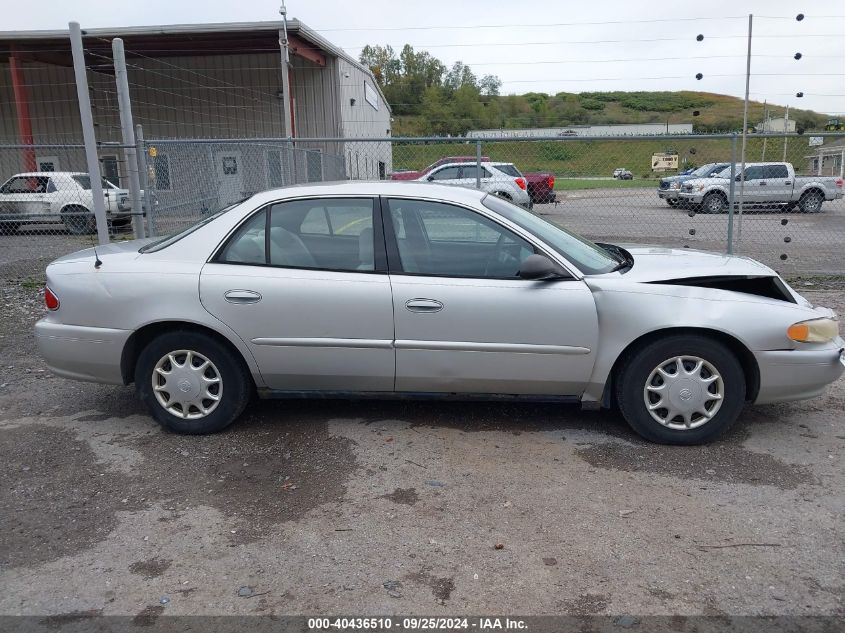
[244, 180, 487, 204]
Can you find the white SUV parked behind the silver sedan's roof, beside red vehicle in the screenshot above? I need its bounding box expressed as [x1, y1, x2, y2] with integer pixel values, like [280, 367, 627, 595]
[417, 162, 533, 209]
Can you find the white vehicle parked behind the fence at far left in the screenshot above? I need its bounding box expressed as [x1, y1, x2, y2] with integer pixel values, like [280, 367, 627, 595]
[0, 171, 132, 235]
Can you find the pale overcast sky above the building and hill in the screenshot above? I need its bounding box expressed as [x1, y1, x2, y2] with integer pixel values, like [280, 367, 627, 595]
[6, 0, 845, 113]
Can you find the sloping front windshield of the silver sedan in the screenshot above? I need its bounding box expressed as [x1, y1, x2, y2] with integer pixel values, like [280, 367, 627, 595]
[481, 195, 619, 275]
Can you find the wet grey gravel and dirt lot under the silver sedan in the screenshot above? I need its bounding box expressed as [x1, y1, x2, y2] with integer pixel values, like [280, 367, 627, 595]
[0, 286, 845, 622]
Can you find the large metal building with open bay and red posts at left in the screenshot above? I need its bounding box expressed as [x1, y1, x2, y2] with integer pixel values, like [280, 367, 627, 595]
[0, 20, 392, 204]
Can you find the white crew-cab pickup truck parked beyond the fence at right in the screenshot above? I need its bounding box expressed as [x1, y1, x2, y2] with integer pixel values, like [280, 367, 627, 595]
[678, 163, 842, 213]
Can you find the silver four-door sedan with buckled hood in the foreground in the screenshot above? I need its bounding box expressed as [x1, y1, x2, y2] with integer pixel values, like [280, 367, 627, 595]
[36, 181, 845, 444]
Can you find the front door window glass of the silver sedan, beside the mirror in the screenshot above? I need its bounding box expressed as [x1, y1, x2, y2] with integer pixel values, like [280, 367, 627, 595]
[388, 200, 535, 279]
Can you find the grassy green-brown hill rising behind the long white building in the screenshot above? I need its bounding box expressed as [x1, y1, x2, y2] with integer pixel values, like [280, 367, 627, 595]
[393, 91, 829, 136]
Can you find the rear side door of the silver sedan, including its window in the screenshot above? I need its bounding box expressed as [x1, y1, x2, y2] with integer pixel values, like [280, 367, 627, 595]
[200, 198, 395, 391]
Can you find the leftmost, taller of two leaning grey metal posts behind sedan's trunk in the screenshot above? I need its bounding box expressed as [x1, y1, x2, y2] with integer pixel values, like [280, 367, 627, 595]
[68, 22, 109, 244]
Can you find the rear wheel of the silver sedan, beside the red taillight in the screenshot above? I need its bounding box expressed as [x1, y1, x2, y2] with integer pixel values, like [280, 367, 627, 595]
[135, 331, 251, 435]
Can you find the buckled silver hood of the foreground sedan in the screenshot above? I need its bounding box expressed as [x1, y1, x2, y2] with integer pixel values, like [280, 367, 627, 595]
[619, 244, 777, 282]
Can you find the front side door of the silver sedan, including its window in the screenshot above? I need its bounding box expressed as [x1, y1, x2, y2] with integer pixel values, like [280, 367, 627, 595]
[382, 198, 598, 396]
